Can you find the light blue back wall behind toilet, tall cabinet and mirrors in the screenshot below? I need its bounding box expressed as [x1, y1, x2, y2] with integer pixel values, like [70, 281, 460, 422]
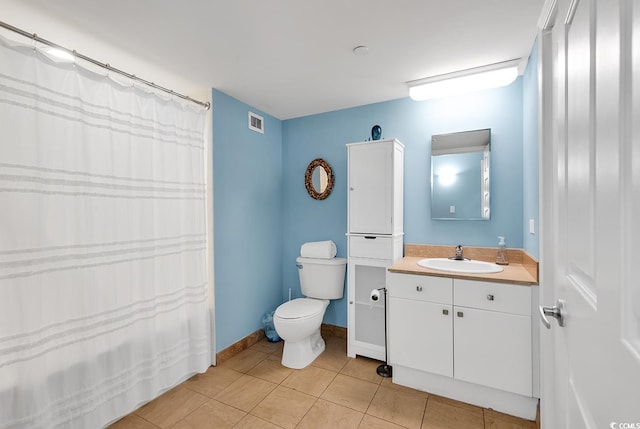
[282, 78, 523, 326]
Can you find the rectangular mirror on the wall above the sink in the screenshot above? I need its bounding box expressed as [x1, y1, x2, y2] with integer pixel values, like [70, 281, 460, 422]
[431, 129, 491, 220]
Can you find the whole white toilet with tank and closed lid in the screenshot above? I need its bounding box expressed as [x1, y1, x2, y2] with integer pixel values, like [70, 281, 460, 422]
[273, 257, 347, 369]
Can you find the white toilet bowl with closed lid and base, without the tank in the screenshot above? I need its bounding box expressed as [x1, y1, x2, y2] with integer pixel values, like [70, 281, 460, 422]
[273, 298, 329, 369]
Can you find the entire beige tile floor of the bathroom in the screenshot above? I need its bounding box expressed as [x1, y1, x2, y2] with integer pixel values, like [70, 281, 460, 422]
[110, 336, 536, 429]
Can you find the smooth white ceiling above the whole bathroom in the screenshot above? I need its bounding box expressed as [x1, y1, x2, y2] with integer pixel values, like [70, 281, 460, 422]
[17, 0, 544, 119]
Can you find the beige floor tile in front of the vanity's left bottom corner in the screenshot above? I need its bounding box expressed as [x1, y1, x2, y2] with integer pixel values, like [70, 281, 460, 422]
[367, 386, 427, 429]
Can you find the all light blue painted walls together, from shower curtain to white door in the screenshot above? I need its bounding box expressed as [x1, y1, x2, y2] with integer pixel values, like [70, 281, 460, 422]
[213, 57, 538, 342]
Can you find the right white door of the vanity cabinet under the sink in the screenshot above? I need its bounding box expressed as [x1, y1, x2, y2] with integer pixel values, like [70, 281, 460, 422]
[453, 307, 532, 396]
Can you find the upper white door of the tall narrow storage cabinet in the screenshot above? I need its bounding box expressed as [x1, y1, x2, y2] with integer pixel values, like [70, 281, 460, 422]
[348, 143, 393, 234]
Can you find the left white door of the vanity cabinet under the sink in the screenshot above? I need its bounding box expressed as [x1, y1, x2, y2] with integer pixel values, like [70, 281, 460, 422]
[389, 298, 453, 377]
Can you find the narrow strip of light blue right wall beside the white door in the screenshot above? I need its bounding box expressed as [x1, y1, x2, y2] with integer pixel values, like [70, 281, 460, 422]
[522, 41, 540, 258]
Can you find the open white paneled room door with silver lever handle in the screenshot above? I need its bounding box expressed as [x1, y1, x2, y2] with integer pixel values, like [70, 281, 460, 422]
[540, 0, 640, 429]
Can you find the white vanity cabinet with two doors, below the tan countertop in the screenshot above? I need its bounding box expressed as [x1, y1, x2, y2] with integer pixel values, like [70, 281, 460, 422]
[387, 272, 538, 419]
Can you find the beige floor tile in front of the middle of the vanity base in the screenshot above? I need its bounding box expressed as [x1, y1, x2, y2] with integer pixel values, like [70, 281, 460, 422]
[422, 395, 484, 429]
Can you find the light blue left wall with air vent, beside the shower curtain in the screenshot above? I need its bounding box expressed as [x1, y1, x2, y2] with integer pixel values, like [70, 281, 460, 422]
[213, 90, 283, 351]
